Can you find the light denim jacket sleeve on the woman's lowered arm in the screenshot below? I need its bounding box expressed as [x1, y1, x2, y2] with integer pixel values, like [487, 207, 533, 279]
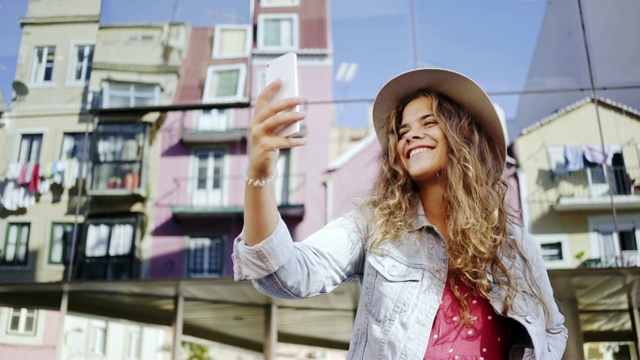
[513, 226, 569, 359]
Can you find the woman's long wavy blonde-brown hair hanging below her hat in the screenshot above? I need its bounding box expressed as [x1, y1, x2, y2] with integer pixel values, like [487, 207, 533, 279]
[361, 90, 550, 324]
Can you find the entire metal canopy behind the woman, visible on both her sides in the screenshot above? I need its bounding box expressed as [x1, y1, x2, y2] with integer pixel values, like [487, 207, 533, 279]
[0, 267, 640, 352]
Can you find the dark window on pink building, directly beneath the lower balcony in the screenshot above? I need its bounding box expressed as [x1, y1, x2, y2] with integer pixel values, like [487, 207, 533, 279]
[189, 238, 223, 277]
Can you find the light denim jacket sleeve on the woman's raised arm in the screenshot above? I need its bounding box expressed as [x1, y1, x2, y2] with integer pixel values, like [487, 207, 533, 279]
[232, 211, 364, 299]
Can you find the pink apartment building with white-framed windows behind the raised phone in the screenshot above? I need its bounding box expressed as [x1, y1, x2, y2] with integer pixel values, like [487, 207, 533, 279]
[150, 0, 332, 278]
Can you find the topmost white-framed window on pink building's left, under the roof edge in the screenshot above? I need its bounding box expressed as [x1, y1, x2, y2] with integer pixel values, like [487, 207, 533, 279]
[211, 25, 251, 59]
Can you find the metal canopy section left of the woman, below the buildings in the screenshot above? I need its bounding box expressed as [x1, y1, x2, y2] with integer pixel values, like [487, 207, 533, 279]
[0, 279, 360, 352]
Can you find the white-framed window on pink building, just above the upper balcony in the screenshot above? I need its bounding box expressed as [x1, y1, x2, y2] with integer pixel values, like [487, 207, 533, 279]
[202, 64, 246, 103]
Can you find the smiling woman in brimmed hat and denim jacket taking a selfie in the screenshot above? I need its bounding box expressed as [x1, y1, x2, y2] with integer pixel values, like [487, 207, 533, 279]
[233, 69, 567, 360]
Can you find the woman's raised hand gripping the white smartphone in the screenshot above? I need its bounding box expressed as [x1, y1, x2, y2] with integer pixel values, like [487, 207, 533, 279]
[247, 80, 306, 179]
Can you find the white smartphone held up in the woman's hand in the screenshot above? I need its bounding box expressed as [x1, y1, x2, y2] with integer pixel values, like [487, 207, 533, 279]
[264, 52, 300, 136]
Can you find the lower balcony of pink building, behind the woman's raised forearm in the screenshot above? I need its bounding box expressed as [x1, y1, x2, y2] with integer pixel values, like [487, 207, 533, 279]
[168, 175, 306, 220]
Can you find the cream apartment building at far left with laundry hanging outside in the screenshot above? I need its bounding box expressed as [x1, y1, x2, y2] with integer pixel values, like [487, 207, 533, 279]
[0, 0, 189, 359]
